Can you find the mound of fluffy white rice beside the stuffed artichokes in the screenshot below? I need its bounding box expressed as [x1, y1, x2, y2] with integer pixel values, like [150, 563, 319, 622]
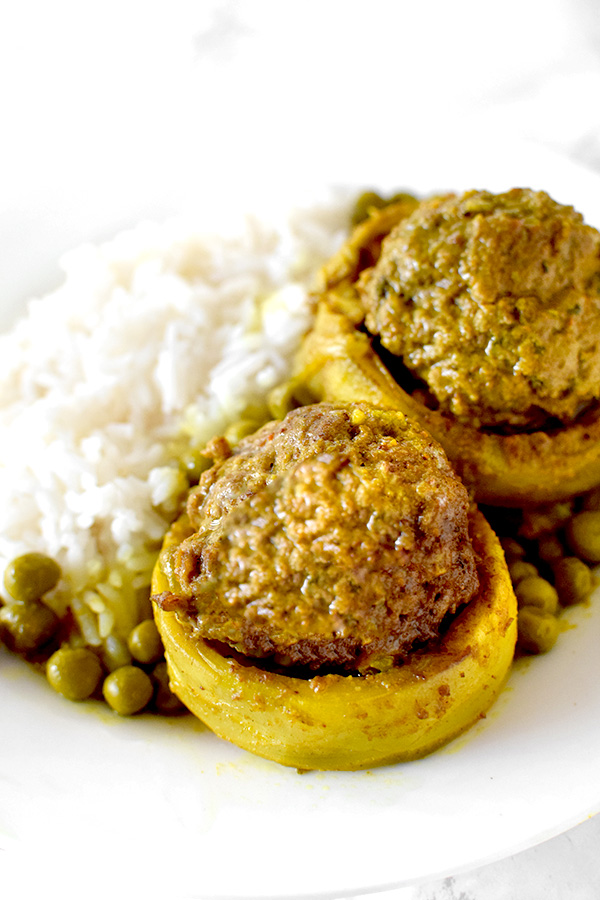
[0, 197, 347, 645]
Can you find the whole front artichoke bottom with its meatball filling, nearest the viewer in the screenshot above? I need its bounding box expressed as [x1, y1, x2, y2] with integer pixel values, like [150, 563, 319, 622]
[152, 403, 517, 770]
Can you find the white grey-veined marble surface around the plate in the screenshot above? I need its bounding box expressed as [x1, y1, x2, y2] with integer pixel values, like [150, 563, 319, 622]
[0, 0, 600, 900]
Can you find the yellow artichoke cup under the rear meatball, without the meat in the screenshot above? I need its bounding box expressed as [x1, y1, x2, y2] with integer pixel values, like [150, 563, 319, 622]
[288, 201, 600, 508]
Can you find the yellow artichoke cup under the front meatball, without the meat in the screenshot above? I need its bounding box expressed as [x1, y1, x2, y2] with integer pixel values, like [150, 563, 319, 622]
[152, 512, 517, 770]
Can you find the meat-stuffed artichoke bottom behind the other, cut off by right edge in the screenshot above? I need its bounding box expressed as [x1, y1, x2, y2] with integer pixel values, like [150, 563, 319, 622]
[289, 189, 600, 508]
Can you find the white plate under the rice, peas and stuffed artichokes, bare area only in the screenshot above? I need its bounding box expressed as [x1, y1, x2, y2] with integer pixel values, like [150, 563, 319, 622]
[0, 138, 600, 898]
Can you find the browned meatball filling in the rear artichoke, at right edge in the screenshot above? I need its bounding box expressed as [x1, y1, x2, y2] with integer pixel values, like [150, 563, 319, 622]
[360, 189, 600, 427]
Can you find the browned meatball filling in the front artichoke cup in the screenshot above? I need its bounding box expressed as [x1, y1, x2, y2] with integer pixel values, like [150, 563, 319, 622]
[159, 404, 478, 670]
